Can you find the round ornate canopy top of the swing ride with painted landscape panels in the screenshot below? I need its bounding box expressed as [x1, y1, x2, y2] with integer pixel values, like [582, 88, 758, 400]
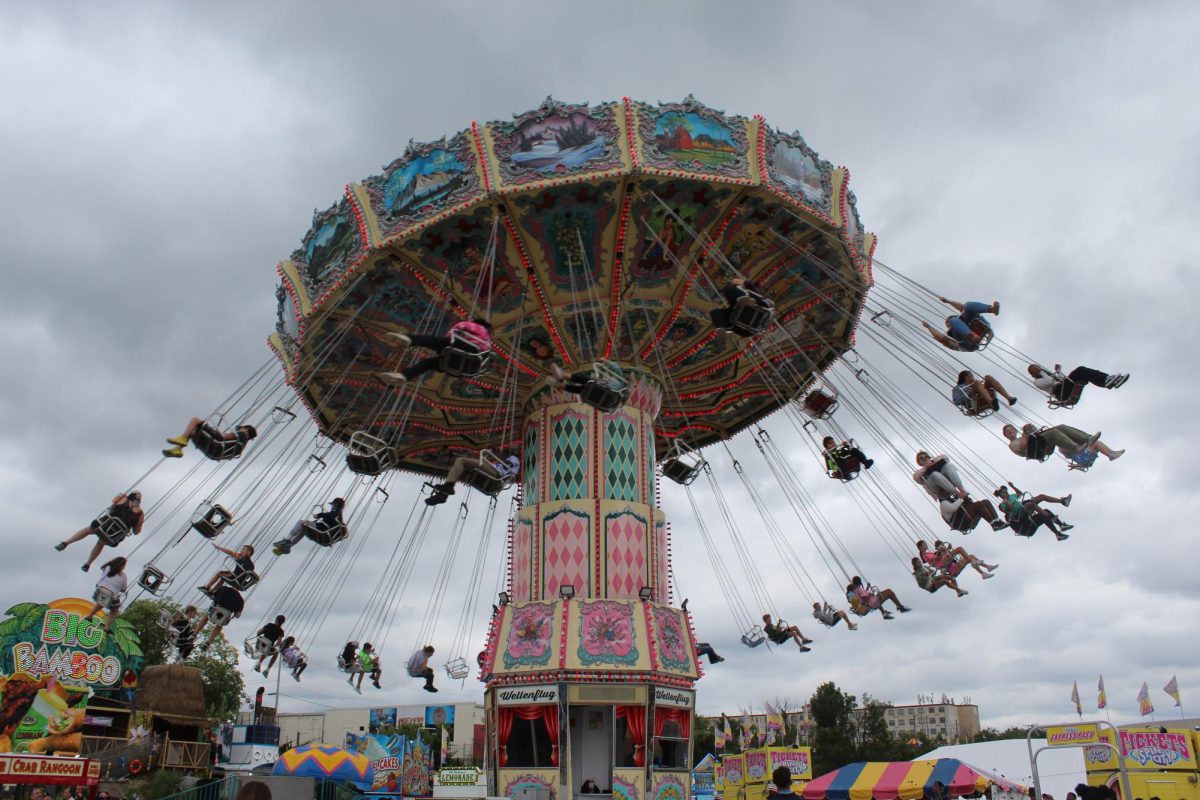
[271, 97, 875, 474]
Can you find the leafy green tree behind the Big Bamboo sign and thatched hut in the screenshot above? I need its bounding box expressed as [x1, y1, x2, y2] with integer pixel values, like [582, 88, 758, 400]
[118, 600, 246, 722]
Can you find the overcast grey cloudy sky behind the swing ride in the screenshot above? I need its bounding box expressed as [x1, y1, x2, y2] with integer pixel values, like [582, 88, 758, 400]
[0, 1, 1200, 727]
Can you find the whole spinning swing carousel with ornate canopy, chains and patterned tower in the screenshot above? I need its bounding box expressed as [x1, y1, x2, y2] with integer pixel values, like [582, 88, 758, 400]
[54, 97, 1123, 799]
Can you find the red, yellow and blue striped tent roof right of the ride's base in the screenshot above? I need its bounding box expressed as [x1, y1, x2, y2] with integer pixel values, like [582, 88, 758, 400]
[803, 758, 1024, 800]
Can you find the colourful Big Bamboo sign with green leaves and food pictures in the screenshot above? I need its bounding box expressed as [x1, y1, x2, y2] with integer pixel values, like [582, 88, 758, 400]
[0, 597, 142, 753]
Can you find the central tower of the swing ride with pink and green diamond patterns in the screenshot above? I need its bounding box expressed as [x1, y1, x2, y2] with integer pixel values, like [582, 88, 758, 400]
[482, 371, 698, 800]
